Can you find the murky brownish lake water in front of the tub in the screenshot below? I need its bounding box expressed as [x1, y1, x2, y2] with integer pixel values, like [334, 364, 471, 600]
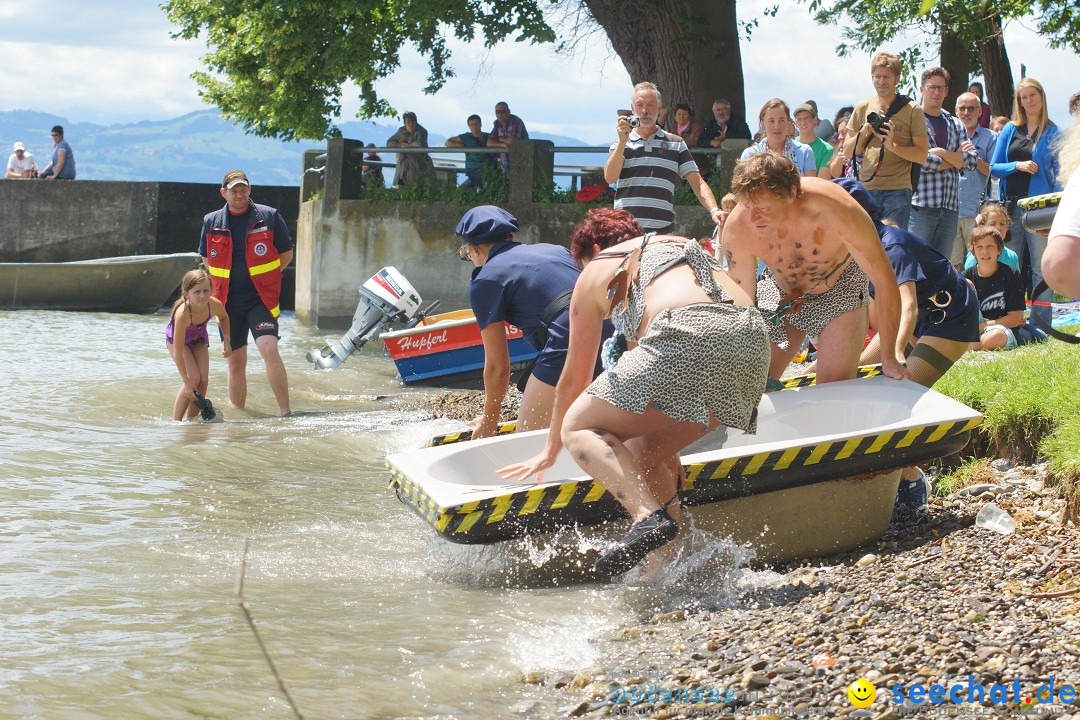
[0, 312, 769, 719]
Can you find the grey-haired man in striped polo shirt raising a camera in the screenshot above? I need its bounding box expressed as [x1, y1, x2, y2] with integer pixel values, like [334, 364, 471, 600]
[604, 82, 721, 233]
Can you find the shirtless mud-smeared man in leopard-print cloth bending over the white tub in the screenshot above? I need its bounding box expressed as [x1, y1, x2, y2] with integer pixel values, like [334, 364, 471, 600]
[724, 152, 906, 383]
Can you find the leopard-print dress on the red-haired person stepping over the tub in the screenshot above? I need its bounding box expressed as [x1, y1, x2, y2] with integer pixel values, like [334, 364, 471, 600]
[585, 241, 769, 433]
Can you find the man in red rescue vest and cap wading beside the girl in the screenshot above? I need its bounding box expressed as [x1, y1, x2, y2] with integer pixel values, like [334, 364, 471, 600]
[199, 169, 293, 416]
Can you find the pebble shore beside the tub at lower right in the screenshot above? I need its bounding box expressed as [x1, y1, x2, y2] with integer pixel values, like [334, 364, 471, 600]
[401, 392, 1080, 720]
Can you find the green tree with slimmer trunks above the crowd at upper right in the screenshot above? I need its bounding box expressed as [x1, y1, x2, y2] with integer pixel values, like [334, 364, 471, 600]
[800, 0, 1080, 114]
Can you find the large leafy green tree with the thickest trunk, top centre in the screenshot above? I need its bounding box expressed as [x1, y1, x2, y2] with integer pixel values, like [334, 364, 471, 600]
[163, 0, 774, 139]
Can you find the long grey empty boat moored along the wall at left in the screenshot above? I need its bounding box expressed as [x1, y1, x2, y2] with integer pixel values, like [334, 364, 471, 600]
[0, 253, 201, 313]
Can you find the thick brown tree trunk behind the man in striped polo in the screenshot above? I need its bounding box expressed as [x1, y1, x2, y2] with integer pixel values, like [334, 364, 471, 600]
[583, 0, 746, 123]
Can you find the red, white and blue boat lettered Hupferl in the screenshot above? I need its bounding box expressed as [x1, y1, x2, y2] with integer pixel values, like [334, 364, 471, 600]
[379, 310, 537, 388]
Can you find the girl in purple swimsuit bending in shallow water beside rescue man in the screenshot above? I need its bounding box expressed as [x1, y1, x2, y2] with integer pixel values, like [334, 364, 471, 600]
[165, 268, 232, 420]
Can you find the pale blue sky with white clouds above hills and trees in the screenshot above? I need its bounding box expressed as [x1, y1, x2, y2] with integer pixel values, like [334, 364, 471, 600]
[0, 0, 1080, 145]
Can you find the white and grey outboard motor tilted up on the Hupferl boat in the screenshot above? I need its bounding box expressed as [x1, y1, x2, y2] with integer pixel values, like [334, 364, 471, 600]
[308, 268, 427, 370]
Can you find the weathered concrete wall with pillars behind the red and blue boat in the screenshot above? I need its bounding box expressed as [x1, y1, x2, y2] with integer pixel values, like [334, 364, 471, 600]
[296, 138, 746, 328]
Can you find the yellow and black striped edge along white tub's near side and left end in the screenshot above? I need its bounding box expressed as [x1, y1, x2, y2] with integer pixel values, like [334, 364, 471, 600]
[388, 418, 982, 543]
